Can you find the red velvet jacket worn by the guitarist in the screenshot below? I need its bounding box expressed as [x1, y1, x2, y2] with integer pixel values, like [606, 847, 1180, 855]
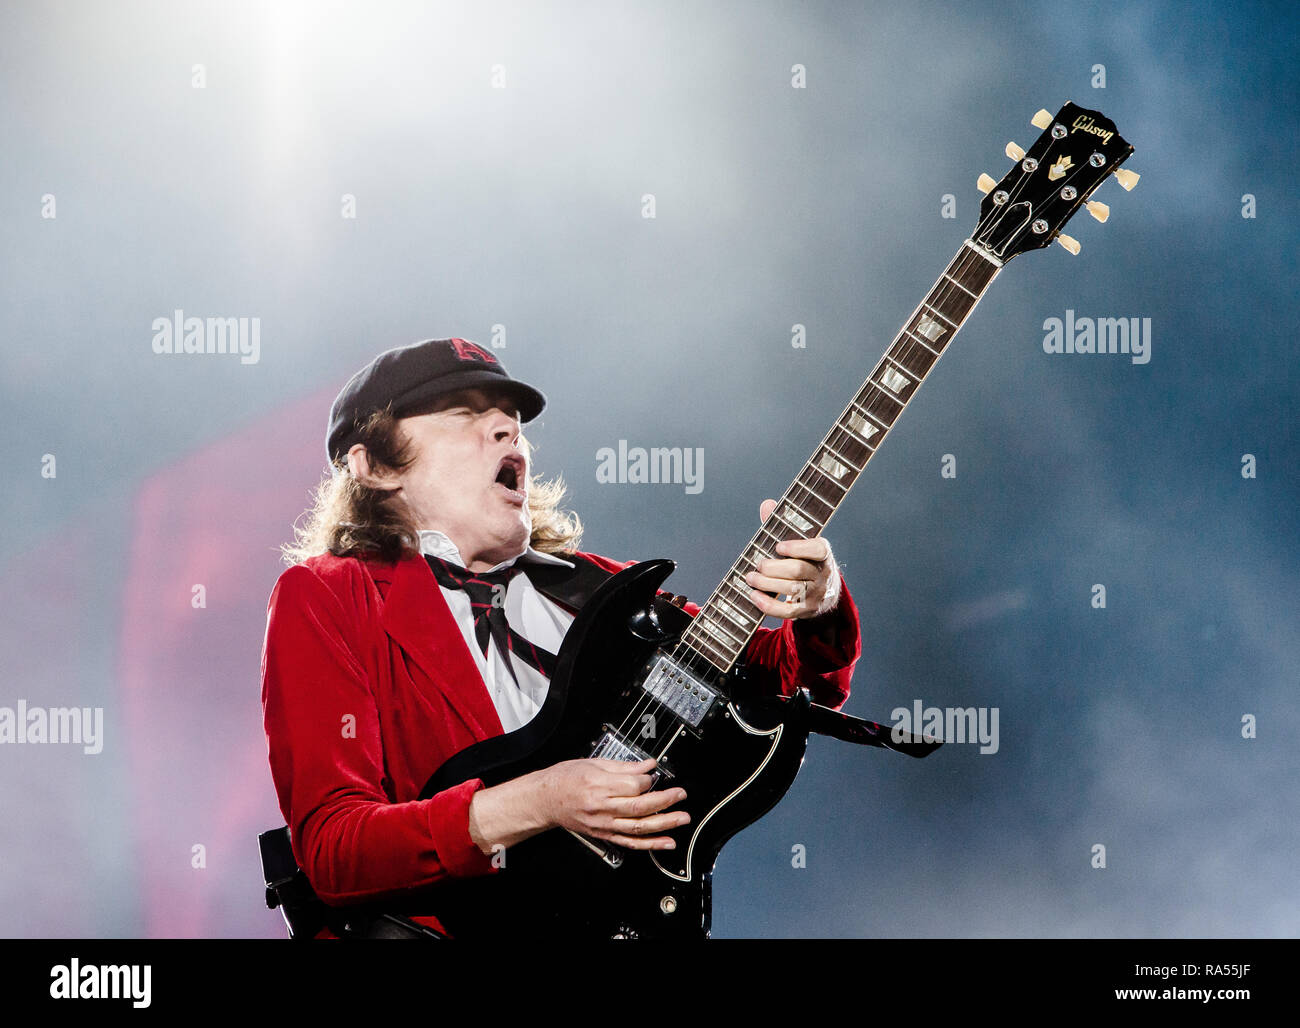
[261, 554, 861, 928]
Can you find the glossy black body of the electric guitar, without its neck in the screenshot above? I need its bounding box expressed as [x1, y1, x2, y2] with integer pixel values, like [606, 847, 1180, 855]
[412, 560, 809, 941]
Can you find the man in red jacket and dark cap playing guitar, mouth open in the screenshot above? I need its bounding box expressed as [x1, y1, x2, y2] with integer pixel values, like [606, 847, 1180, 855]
[263, 339, 859, 937]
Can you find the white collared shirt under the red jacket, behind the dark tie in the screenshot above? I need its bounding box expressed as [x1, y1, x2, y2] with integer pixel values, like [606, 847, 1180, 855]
[420, 530, 573, 732]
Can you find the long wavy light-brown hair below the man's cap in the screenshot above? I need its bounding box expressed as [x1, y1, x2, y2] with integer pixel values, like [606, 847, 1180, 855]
[287, 404, 582, 565]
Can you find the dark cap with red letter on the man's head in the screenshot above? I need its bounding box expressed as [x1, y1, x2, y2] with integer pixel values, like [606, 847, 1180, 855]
[325, 339, 546, 461]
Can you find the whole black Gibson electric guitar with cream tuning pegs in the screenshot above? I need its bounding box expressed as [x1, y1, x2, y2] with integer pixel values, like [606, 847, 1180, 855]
[408, 103, 1138, 942]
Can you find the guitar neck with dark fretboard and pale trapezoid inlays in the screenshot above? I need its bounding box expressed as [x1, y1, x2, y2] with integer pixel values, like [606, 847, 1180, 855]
[680, 239, 1002, 672]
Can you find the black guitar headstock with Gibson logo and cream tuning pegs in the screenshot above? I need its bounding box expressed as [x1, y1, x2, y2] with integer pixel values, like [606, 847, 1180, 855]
[971, 104, 1138, 263]
